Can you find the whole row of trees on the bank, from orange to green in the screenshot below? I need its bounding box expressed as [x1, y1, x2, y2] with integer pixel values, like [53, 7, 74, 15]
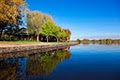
[0, 0, 71, 42]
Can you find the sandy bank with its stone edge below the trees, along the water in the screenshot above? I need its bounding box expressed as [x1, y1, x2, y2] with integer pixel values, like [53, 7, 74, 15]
[0, 42, 78, 54]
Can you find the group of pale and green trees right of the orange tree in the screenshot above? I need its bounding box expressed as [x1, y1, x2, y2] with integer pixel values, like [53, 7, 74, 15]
[27, 11, 71, 42]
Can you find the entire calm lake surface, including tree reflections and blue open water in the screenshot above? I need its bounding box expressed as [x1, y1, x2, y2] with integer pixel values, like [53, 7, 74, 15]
[0, 44, 120, 80]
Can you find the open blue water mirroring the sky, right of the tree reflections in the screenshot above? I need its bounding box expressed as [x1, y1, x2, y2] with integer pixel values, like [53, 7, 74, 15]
[46, 45, 120, 80]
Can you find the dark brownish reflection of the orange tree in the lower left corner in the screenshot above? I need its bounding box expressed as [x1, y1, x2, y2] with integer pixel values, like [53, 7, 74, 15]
[0, 58, 25, 80]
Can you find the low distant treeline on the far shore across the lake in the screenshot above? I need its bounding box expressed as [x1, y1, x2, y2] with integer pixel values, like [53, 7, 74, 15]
[76, 39, 120, 45]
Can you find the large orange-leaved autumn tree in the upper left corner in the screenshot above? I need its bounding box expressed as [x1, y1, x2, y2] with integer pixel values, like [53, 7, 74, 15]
[0, 0, 25, 37]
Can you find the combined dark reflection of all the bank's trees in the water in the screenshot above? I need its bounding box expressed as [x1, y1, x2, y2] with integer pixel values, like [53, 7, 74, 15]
[0, 47, 71, 80]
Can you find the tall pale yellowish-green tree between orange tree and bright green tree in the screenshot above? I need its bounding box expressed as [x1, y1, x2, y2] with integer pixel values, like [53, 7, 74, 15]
[27, 11, 46, 41]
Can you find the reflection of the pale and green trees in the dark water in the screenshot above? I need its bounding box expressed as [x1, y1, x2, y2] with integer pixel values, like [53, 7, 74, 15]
[27, 51, 71, 76]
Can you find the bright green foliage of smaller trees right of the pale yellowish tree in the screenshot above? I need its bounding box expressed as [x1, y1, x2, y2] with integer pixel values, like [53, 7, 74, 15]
[40, 21, 67, 41]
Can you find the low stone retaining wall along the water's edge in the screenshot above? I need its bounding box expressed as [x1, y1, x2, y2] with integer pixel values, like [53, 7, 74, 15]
[0, 42, 78, 54]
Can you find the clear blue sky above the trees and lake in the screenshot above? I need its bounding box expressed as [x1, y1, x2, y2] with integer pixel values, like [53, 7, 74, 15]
[27, 0, 120, 39]
